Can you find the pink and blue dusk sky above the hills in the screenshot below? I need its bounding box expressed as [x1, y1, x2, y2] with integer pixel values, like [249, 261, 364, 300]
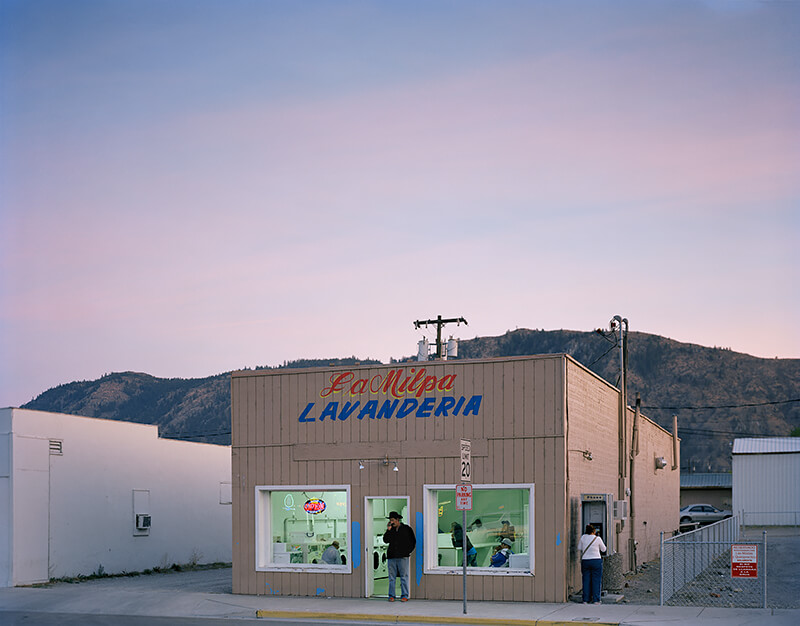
[0, 0, 800, 406]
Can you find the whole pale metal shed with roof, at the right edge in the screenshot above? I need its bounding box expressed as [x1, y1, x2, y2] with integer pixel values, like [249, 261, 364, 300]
[733, 437, 800, 526]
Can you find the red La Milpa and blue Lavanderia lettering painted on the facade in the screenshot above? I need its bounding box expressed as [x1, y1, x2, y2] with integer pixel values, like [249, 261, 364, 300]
[298, 367, 483, 423]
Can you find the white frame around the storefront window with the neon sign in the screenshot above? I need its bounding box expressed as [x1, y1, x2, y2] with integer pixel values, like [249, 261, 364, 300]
[255, 485, 353, 574]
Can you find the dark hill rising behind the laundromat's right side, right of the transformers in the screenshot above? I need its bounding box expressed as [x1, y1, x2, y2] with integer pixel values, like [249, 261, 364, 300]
[459, 329, 800, 472]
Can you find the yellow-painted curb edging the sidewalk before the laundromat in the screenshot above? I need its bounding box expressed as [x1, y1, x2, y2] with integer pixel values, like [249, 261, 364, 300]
[256, 609, 620, 626]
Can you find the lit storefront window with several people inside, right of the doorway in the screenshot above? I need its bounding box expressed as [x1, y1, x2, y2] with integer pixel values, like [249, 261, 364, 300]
[425, 485, 533, 574]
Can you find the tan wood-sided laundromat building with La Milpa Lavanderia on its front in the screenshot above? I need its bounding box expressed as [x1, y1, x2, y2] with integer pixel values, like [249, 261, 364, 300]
[231, 354, 680, 602]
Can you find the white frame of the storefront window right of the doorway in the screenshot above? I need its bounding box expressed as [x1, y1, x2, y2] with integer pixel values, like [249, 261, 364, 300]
[422, 483, 536, 576]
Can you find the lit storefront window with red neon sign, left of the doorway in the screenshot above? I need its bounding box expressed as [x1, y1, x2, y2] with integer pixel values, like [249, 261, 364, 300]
[256, 485, 350, 571]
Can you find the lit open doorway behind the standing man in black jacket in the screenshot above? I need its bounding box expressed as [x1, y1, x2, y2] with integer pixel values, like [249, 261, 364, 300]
[364, 496, 410, 598]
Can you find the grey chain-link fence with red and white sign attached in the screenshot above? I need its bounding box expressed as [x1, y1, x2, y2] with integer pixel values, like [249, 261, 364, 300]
[660, 517, 767, 608]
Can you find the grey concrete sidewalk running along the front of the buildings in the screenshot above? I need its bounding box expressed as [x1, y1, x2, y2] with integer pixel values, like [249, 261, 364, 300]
[0, 570, 800, 626]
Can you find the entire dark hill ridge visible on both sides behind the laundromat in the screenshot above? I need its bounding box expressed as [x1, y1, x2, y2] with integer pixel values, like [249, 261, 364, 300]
[23, 329, 800, 472]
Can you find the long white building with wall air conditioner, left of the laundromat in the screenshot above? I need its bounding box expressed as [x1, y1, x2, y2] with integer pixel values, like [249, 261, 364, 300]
[0, 408, 231, 587]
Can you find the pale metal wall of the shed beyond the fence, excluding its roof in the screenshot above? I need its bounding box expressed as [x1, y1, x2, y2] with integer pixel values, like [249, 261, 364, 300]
[732, 453, 800, 526]
